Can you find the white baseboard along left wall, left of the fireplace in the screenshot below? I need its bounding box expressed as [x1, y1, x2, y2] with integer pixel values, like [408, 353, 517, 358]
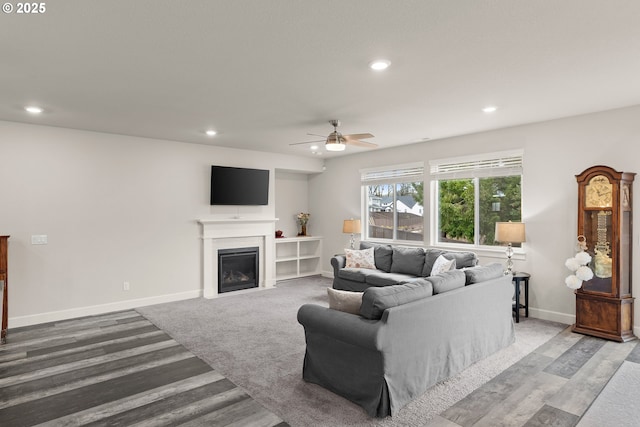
[8, 289, 202, 330]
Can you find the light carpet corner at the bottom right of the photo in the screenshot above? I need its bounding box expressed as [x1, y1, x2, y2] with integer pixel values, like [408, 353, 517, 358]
[578, 361, 640, 427]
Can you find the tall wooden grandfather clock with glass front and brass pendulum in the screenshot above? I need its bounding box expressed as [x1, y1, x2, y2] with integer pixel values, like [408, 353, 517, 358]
[573, 166, 635, 342]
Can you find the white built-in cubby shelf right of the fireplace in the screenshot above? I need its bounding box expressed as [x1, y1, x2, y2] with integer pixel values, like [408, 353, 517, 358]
[276, 236, 322, 280]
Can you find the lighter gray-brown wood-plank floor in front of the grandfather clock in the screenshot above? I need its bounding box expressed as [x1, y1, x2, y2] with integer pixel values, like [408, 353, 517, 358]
[428, 328, 640, 427]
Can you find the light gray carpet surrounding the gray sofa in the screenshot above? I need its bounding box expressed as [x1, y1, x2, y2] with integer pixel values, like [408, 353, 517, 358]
[138, 276, 566, 426]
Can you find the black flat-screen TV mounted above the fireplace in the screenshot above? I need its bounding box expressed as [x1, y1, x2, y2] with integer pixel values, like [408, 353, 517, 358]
[211, 166, 269, 206]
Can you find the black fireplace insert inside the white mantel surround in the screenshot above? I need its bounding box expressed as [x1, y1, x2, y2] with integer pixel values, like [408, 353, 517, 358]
[218, 246, 260, 293]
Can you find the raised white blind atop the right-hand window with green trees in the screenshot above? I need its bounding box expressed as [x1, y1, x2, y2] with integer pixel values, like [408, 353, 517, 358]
[429, 150, 523, 180]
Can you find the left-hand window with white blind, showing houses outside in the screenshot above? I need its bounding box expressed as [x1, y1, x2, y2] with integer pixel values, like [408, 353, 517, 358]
[361, 163, 424, 242]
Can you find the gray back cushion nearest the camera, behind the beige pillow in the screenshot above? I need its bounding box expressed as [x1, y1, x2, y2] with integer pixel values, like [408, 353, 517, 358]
[360, 279, 433, 320]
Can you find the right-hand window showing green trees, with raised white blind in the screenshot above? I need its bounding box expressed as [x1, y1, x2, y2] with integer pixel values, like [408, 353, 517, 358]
[430, 151, 523, 246]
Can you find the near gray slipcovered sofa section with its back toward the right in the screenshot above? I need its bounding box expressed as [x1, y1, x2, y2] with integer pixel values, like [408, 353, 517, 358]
[298, 242, 515, 417]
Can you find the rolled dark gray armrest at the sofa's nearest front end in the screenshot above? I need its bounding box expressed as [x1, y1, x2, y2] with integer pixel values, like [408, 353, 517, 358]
[298, 304, 383, 350]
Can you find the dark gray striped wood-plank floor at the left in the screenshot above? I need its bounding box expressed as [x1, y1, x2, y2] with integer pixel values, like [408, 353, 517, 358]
[0, 311, 287, 427]
